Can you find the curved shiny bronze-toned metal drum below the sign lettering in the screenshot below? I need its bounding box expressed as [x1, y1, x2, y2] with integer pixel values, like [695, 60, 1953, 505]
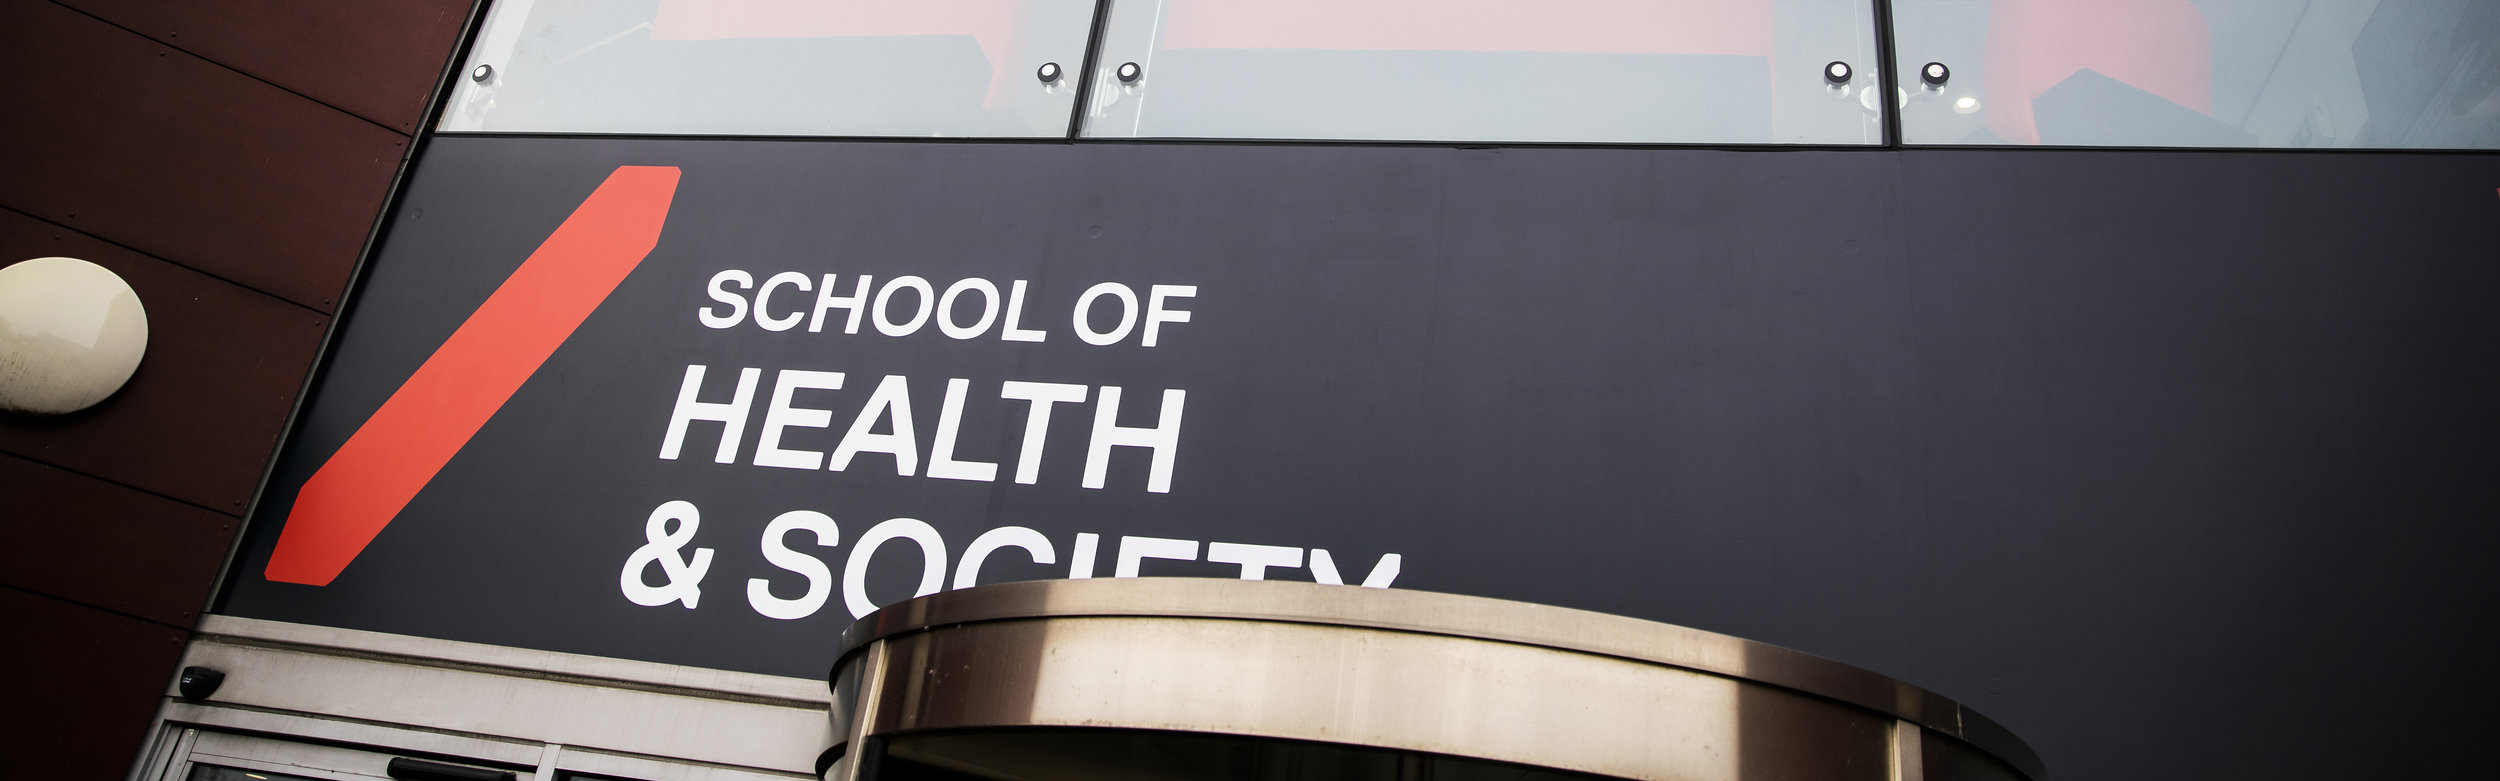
[828, 578, 2043, 781]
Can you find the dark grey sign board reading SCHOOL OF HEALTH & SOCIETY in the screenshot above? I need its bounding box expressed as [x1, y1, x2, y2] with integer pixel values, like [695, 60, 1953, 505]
[225, 138, 2500, 773]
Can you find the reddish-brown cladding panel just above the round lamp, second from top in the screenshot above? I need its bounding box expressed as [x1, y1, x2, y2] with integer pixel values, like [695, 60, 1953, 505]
[0, 0, 408, 310]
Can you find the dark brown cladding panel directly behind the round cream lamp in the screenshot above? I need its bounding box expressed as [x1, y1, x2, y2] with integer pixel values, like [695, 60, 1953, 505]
[0, 210, 330, 510]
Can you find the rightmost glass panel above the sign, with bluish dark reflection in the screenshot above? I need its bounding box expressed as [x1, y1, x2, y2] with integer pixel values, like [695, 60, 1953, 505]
[1893, 0, 2500, 150]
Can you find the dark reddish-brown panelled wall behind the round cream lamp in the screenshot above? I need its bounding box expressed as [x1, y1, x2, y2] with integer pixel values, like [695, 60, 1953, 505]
[0, 0, 470, 781]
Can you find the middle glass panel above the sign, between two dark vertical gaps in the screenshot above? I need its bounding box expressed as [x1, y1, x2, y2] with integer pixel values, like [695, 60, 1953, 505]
[1085, 0, 1883, 145]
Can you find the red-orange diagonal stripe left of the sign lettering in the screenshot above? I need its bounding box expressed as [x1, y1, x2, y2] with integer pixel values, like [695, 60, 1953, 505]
[265, 165, 678, 586]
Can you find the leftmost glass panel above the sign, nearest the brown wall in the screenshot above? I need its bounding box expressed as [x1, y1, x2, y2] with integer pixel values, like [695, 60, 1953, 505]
[443, 0, 1093, 138]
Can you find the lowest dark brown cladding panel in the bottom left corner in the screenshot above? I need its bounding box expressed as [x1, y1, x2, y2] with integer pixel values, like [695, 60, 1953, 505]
[0, 588, 188, 781]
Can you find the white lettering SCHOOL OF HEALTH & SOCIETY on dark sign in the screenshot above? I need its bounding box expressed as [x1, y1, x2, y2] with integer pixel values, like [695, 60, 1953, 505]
[618, 268, 1405, 621]
